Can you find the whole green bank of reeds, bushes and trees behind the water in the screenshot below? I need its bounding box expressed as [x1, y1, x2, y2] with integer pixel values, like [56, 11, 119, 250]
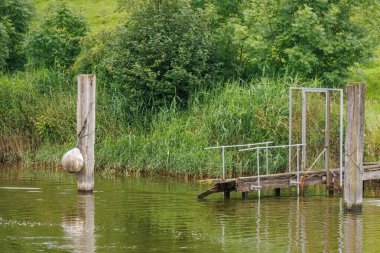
[0, 0, 380, 179]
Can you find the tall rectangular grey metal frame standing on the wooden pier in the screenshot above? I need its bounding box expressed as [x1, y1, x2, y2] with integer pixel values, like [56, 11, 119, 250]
[289, 87, 343, 187]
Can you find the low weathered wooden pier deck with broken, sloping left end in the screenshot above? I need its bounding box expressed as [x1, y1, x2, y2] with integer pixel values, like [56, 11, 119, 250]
[198, 163, 380, 199]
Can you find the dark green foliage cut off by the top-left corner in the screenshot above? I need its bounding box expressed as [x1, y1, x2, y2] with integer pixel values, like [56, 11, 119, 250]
[0, 0, 33, 70]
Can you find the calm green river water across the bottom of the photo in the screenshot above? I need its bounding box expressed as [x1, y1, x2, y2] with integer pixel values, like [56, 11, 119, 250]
[0, 171, 380, 253]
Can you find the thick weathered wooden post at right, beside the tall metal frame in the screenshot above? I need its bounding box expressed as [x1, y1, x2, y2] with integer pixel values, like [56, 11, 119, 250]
[344, 83, 366, 212]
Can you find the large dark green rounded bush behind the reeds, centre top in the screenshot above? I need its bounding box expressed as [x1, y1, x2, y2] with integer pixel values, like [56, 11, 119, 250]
[78, 0, 216, 108]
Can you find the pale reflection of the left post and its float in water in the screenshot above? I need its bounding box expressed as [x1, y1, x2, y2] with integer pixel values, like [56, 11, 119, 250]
[62, 194, 95, 253]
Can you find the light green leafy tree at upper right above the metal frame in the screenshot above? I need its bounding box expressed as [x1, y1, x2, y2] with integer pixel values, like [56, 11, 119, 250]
[234, 0, 373, 84]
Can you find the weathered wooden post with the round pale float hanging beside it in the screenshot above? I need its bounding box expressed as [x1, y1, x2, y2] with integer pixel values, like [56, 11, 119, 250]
[77, 75, 96, 192]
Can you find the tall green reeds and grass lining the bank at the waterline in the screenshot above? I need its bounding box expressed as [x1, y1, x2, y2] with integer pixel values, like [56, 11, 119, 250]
[0, 70, 380, 178]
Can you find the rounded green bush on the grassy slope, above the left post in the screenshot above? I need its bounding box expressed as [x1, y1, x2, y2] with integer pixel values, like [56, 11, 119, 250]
[25, 4, 88, 69]
